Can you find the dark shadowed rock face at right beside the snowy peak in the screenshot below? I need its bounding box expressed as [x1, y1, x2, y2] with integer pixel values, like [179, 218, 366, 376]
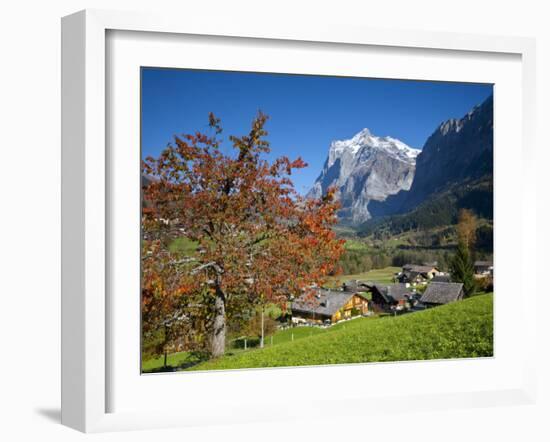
[368, 96, 493, 216]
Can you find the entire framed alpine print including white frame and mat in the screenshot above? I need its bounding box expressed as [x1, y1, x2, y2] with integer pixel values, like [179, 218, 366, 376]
[62, 11, 535, 431]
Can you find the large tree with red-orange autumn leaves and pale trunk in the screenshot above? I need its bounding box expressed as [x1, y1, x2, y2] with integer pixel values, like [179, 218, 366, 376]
[142, 113, 343, 357]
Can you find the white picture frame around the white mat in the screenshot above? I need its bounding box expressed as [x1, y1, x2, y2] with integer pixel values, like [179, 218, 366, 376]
[62, 10, 536, 432]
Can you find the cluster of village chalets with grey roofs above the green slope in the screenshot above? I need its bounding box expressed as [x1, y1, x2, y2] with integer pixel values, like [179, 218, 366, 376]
[291, 261, 493, 327]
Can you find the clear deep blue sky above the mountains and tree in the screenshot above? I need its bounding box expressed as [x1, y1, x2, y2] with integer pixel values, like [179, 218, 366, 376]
[141, 68, 493, 193]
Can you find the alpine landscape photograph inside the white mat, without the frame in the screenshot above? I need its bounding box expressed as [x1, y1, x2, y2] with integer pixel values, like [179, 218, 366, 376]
[141, 67, 500, 374]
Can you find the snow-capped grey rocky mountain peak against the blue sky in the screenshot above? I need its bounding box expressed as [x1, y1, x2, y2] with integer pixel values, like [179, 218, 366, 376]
[308, 129, 420, 224]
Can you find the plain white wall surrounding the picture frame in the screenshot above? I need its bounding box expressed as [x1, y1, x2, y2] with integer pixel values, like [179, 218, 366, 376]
[0, 0, 550, 441]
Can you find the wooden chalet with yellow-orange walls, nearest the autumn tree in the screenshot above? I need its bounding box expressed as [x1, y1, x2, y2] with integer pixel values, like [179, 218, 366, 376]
[291, 289, 369, 323]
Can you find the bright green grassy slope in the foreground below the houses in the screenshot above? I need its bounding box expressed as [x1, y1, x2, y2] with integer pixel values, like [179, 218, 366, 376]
[192, 294, 493, 370]
